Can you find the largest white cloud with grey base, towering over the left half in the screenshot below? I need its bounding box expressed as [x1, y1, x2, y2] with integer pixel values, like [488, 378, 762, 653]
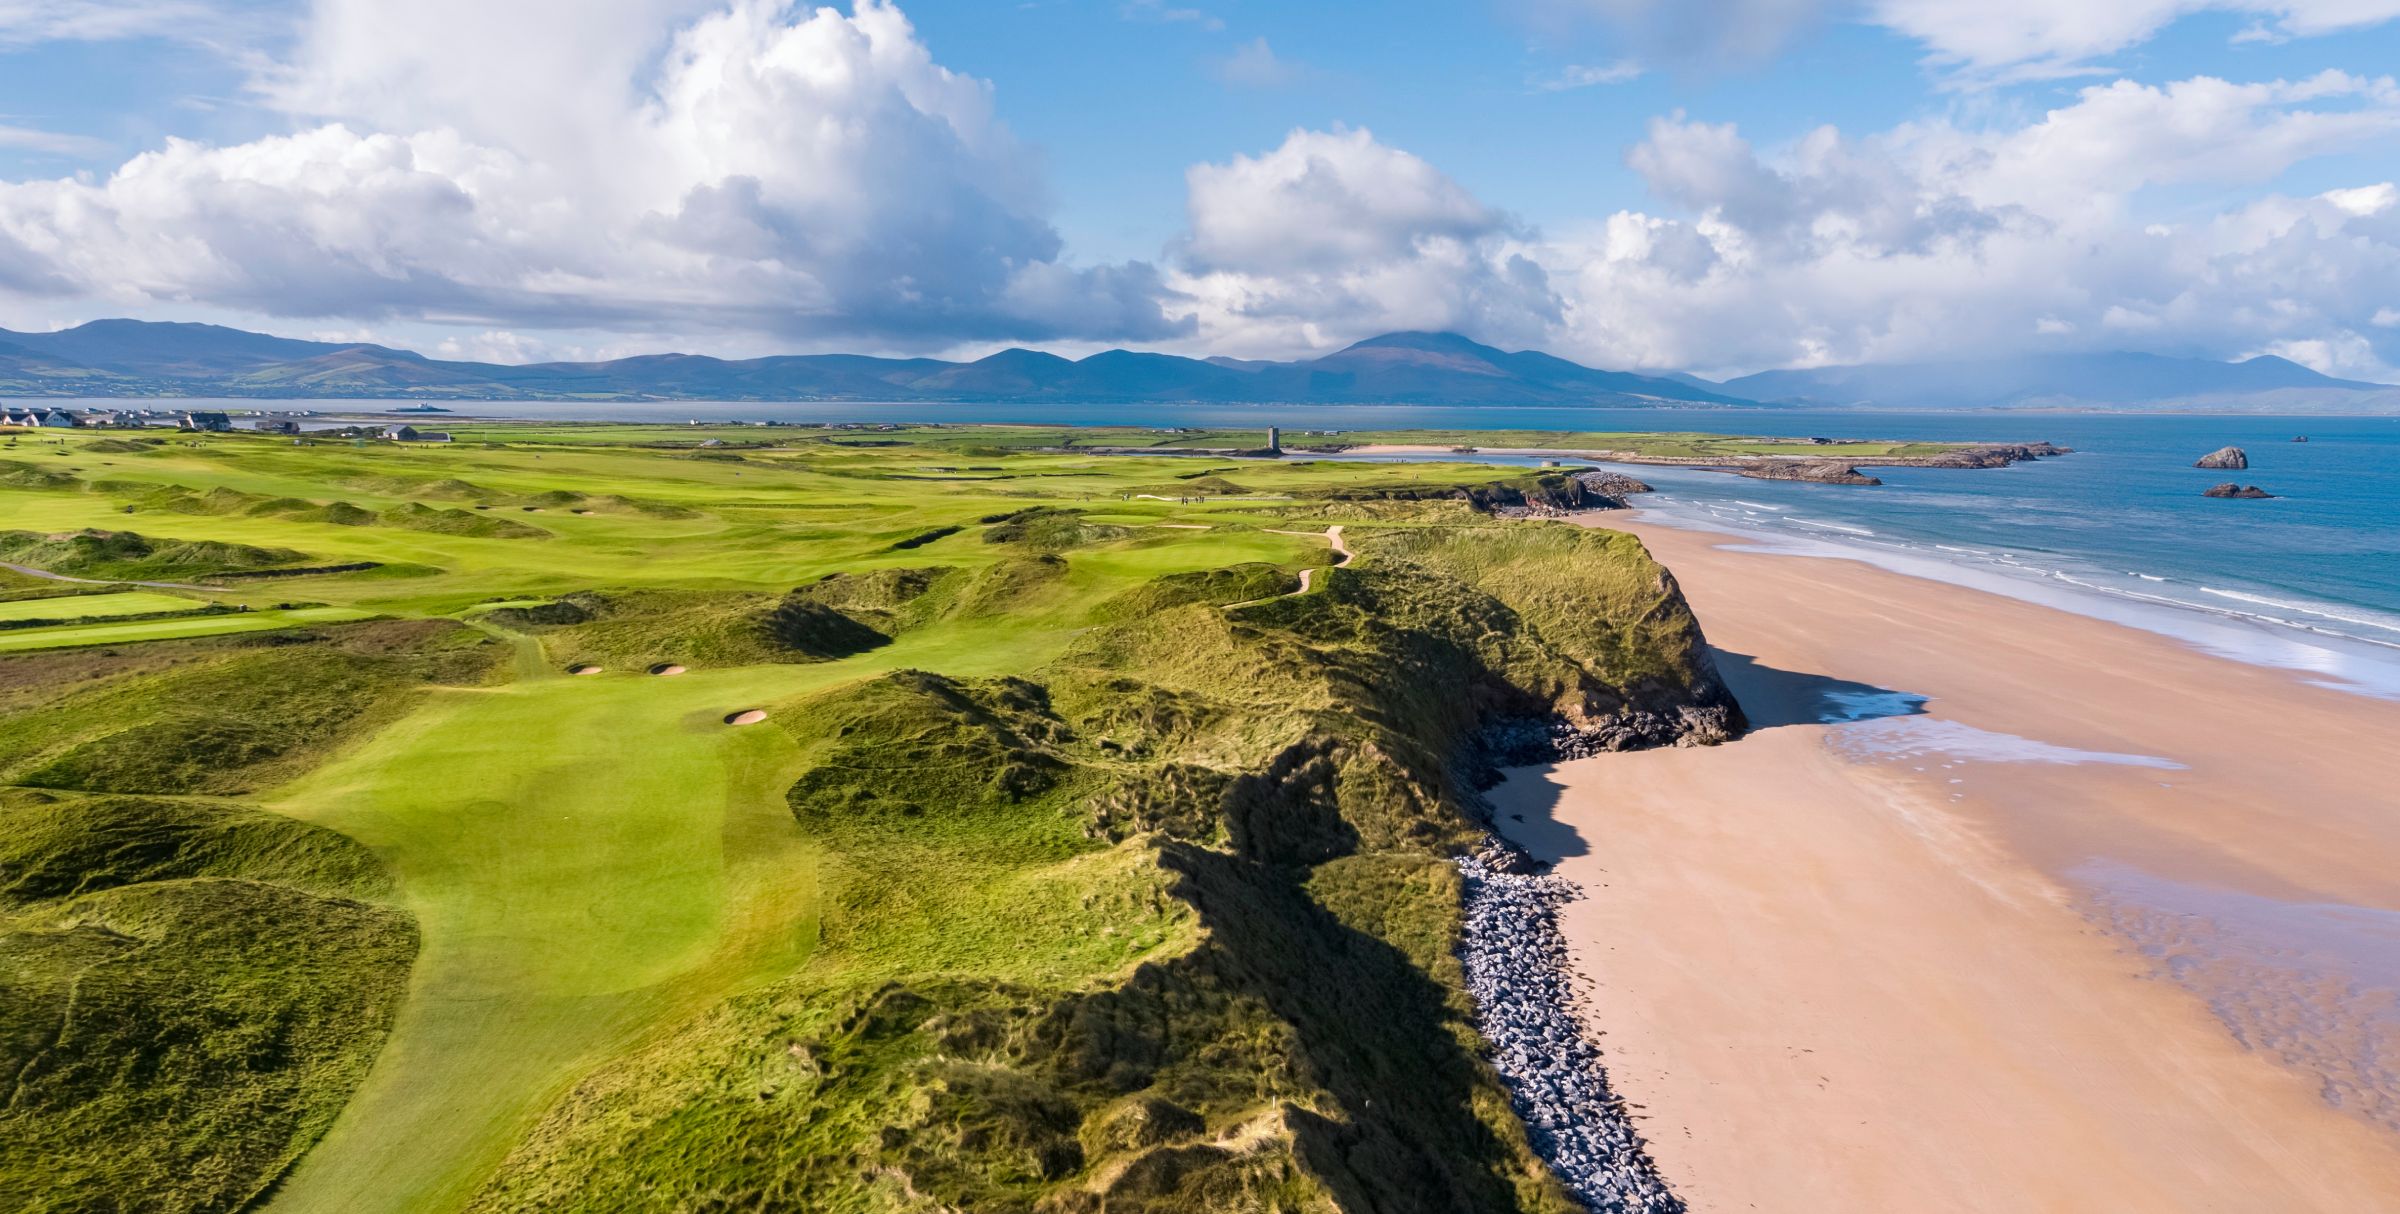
[0, 0, 1178, 345]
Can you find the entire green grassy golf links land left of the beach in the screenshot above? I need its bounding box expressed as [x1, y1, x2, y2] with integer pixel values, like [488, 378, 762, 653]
[0, 425, 1766, 1214]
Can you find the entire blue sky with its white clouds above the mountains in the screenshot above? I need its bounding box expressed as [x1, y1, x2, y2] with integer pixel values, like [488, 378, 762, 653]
[0, 0, 2400, 377]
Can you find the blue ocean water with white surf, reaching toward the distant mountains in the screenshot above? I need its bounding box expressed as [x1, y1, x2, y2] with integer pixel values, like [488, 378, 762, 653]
[108, 401, 2400, 698]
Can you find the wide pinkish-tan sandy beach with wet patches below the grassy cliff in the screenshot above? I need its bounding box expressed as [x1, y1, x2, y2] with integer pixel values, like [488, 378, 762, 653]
[1493, 513, 2400, 1214]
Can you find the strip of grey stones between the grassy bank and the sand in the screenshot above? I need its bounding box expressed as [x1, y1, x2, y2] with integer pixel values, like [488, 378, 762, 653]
[1459, 847, 1685, 1214]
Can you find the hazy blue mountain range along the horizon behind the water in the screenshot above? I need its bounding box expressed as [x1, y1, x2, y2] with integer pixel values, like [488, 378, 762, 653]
[0, 319, 2400, 413]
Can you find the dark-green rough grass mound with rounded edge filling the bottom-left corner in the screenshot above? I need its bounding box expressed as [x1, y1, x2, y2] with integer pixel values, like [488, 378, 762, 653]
[0, 792, 418, 1212]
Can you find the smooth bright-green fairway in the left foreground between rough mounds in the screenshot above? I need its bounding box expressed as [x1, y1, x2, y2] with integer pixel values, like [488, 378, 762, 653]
[269, 667, 850, 1214]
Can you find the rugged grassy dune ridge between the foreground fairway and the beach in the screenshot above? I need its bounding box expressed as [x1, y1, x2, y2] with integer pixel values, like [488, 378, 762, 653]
[458, 525, 1728, 1214]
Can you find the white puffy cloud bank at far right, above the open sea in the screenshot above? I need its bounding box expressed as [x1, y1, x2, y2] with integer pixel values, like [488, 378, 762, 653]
[1534, 74, 2400, 374]
